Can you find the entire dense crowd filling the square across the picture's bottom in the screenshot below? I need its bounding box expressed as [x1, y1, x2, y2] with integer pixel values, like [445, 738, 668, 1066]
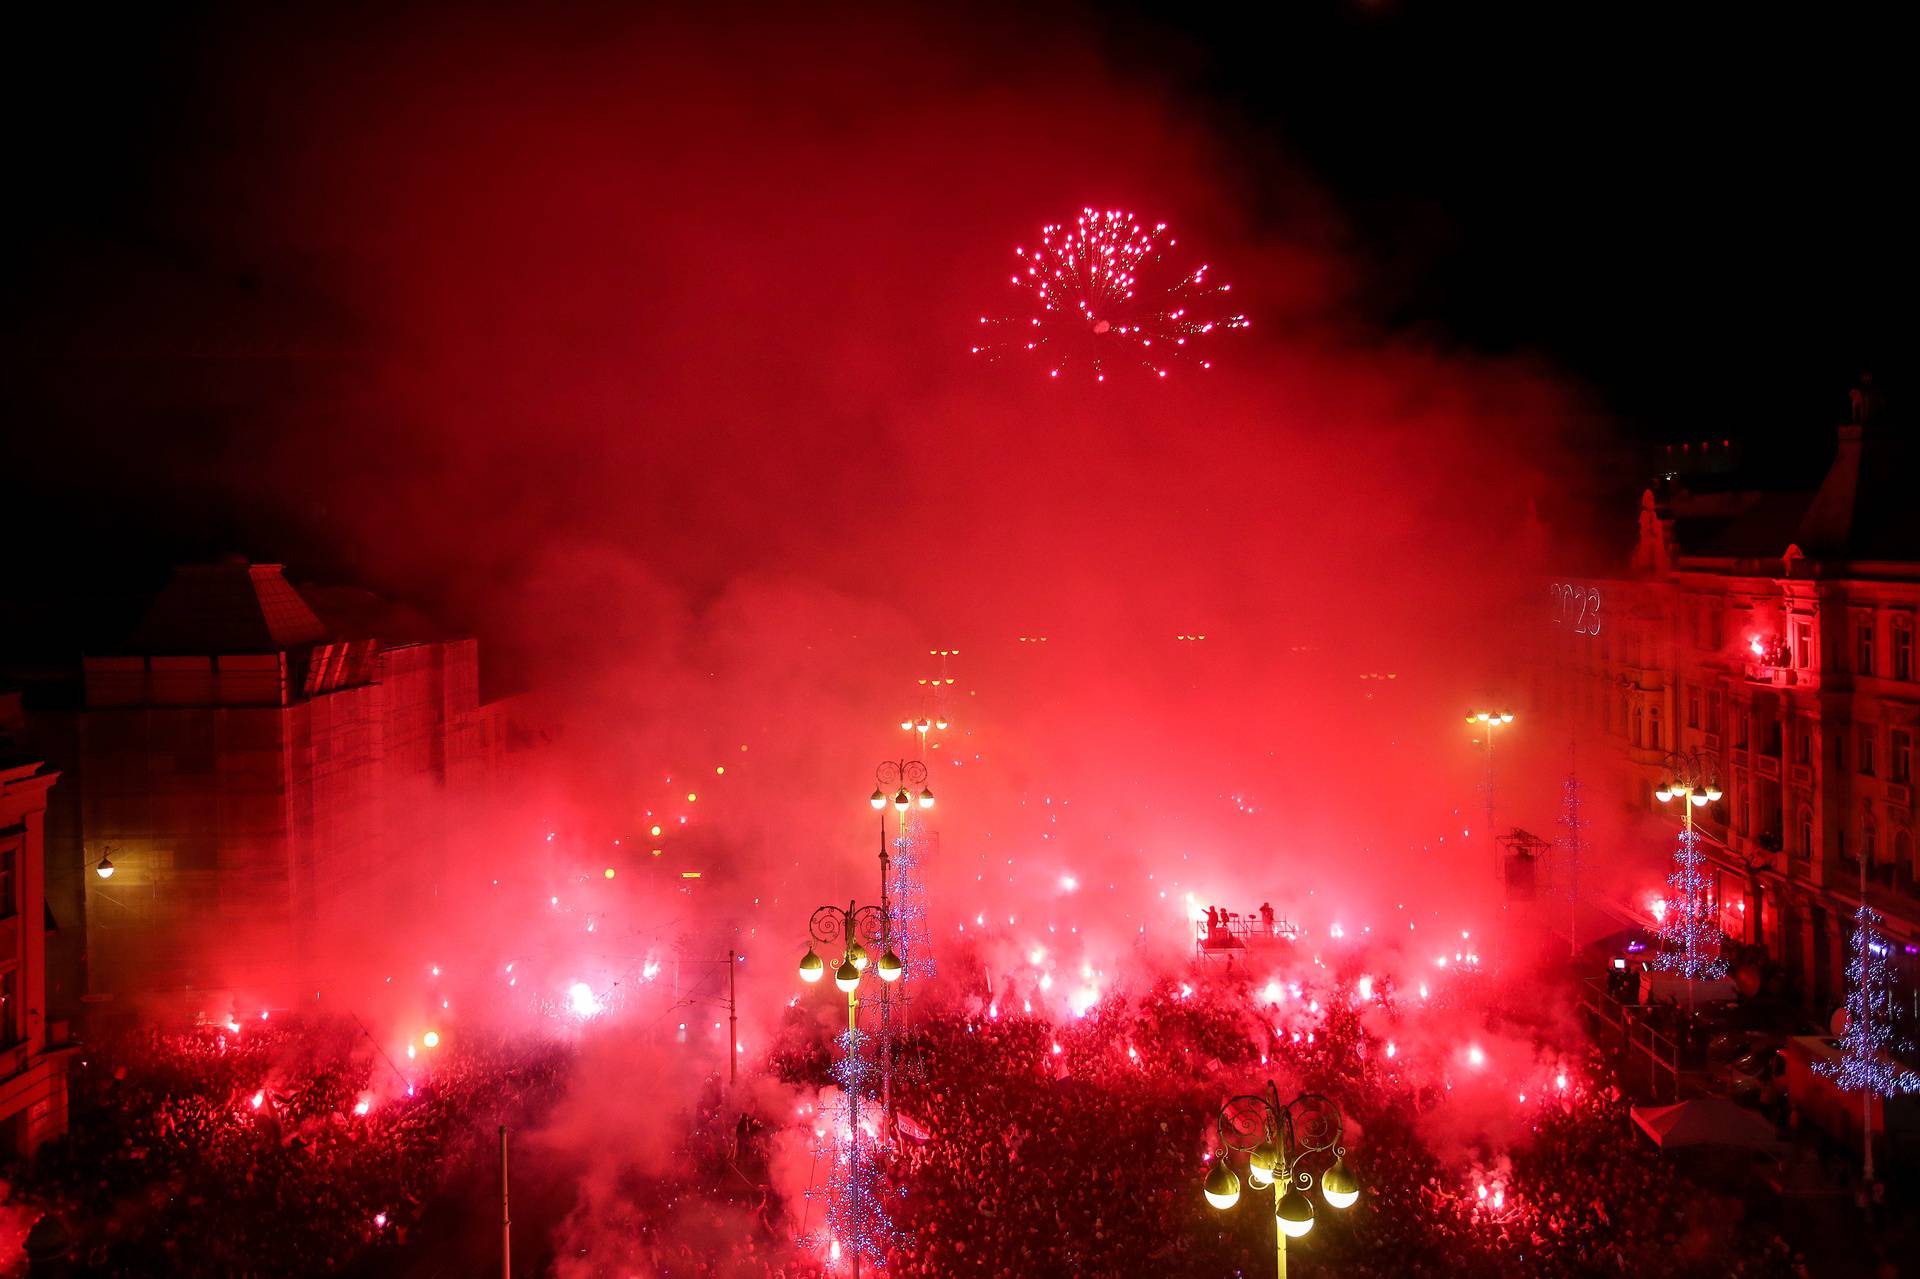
[0, 952, 1873, 1279]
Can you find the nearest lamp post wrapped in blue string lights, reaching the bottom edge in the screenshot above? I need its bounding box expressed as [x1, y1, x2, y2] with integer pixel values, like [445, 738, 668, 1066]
[801, 903, 900, 1279]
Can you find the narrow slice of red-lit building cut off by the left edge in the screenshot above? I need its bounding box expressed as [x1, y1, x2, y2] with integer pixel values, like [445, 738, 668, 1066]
[0, 697, 73, 1154]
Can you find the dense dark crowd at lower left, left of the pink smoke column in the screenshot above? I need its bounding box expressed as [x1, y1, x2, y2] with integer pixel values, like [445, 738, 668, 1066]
[15, 1018, 568, 1275]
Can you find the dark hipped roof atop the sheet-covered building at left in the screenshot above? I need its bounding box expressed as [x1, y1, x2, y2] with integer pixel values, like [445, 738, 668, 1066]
[127, 559, 330, 657]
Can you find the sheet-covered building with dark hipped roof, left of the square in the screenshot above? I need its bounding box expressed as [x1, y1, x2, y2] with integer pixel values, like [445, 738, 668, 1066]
[46, 561, 495, 1012]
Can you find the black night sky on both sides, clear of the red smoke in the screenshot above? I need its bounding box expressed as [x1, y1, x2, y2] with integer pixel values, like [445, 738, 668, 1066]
[0, 2, 1912, 652]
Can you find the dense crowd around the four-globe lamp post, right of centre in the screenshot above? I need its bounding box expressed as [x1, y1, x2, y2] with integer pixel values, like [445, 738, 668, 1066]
[764, 977, 1805, 1279]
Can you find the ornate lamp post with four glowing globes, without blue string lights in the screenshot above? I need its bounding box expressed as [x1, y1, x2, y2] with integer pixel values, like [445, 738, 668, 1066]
[1204, 1079, 1359, 1279]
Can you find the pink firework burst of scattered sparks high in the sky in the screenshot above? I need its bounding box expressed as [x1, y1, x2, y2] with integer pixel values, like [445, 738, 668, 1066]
[973, 209, 1248, 382]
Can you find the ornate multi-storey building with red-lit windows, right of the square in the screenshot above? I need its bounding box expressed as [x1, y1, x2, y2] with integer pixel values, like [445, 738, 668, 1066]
[1538, 422, 1920, 1022]
